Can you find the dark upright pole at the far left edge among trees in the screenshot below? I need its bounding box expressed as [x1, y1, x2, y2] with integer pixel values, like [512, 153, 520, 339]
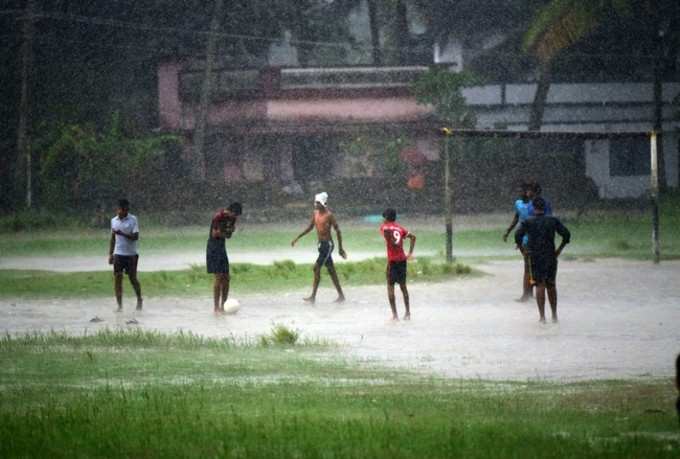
[16, 0, 35, 209]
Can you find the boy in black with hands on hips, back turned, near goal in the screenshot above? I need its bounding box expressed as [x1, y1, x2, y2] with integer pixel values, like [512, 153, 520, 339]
[515, 198, 571, 323]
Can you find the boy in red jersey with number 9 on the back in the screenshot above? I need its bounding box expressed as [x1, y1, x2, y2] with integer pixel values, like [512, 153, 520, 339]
[380, 209, 416, 320]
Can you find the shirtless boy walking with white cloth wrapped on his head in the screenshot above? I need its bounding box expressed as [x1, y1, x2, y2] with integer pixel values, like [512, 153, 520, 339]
[290, 192, 347, 304]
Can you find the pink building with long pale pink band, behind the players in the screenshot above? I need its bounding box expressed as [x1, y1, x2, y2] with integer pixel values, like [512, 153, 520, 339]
[158, 60, 438, 187]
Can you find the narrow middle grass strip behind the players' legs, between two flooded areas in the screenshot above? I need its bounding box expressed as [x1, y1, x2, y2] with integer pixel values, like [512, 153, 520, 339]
[0, 258, 476, 298]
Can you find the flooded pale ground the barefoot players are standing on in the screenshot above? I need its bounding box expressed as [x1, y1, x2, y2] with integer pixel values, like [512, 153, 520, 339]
[0, 259, 680, 381]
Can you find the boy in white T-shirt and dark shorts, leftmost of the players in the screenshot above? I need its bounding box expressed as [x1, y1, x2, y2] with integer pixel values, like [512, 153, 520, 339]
[109, 199, 142, 311]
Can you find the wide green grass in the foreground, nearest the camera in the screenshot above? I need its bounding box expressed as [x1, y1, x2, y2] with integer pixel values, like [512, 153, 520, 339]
[0, 331, 680, 459]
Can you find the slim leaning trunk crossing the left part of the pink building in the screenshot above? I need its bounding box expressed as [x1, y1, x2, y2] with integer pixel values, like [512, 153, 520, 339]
[192, 0, 224, 179]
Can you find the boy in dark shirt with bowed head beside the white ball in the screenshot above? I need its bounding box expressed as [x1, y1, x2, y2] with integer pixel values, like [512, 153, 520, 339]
[206, 202, 243, 313]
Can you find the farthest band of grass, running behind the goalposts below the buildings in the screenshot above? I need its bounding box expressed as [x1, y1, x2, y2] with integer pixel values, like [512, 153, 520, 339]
[0, 198, 680, 260]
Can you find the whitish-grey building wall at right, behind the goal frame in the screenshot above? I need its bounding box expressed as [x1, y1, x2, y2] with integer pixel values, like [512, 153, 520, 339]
[464, 83, 680, 198]
